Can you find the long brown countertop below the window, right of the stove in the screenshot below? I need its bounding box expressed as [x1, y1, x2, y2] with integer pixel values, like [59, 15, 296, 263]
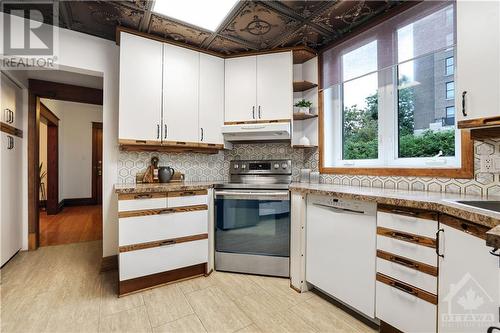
[290, 183, 500, 247]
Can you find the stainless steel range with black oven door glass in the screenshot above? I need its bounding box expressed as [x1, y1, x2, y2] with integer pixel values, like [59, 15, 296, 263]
[215, 160, 292, 277]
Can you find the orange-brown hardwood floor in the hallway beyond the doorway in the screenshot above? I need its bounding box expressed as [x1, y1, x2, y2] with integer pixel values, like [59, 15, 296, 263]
[40, 205, 102, 246]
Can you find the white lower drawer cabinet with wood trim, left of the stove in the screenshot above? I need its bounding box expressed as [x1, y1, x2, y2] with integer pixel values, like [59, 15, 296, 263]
[118, 190, 209, 295]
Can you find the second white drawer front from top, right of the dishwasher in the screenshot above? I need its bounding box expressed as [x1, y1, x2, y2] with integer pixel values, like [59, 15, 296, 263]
[377, 235, 437, 267]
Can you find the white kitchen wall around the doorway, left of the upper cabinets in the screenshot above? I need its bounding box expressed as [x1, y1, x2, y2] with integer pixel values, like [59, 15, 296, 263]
[0, 13, 119, 256]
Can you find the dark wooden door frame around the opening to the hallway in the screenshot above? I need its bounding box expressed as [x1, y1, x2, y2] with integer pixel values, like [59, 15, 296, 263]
[28, 79, 103, 251]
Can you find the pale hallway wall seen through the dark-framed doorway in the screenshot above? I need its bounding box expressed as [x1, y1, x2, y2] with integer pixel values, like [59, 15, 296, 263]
[41, 98, 102, 201]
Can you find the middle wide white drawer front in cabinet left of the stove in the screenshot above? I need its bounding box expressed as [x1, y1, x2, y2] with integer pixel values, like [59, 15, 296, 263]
[119, 210, 208, 246]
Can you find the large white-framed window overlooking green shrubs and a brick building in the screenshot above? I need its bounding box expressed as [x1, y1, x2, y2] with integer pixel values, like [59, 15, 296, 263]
[321, 2, 461, 171]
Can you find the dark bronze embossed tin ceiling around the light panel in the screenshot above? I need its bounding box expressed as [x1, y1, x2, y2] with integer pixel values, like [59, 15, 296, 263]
[3, 0, 404, 54]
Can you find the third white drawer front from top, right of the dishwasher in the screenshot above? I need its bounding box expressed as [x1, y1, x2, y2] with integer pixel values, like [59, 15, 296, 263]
[377, 258, 437, 294]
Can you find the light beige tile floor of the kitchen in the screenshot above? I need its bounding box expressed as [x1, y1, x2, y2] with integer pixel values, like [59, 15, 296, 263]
[0, 241, 374, 333]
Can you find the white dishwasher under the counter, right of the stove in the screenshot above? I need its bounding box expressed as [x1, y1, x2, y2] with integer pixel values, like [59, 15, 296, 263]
[306, 195, 377, 319]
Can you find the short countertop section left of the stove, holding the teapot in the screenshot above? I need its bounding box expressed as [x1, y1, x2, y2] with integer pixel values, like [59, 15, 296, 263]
[115, 182, 217, 194]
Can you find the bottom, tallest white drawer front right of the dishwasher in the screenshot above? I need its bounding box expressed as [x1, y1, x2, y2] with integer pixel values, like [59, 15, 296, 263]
[375, 281, 437, 333]
